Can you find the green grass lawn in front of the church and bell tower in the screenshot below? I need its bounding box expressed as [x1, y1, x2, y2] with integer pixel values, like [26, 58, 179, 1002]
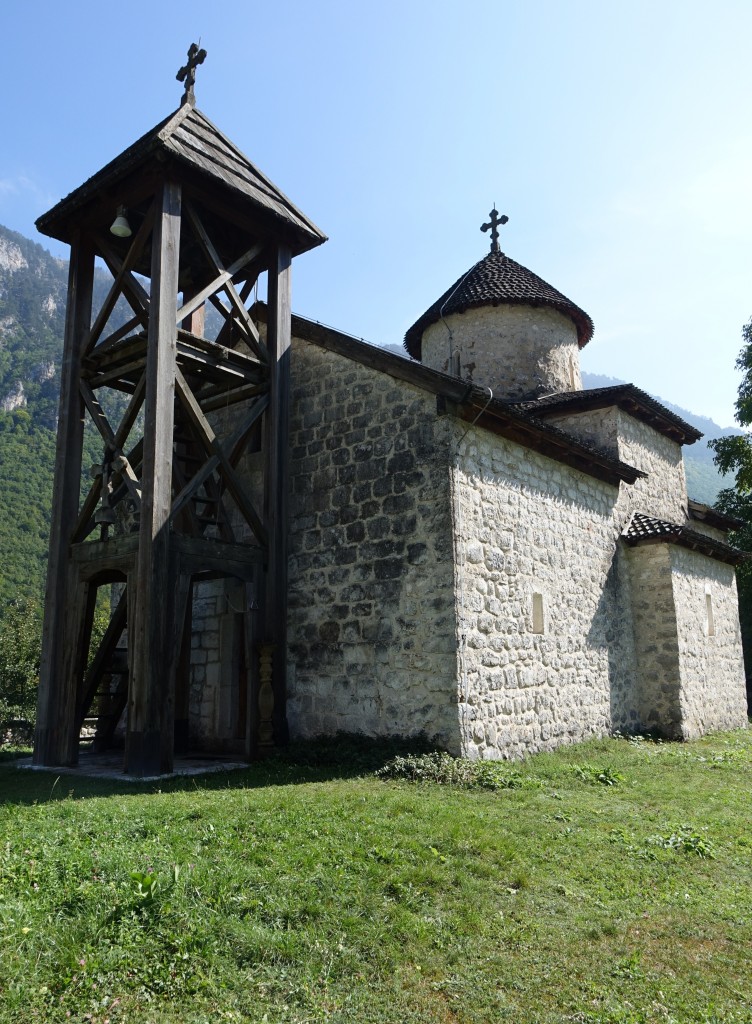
[0, 732, 752, 1024]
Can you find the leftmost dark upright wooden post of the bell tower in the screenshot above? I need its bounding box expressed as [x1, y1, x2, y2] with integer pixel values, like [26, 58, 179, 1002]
[34, 236, 94, 766]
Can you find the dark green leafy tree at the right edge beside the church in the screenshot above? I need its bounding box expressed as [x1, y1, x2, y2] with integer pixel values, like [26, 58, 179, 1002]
[708, 317, 752, 693]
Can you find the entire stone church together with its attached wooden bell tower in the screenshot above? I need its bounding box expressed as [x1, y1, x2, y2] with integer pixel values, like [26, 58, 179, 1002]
[35, 77, 747, 776]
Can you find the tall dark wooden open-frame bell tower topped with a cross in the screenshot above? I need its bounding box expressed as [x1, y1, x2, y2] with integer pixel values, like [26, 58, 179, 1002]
[34, 46, 326, 776]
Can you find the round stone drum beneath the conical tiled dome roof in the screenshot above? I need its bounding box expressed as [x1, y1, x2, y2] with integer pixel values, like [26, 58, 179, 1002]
[422, 305, 582, 398]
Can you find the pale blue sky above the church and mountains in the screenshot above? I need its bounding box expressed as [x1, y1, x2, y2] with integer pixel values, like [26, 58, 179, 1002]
[0, 0, 752, 425]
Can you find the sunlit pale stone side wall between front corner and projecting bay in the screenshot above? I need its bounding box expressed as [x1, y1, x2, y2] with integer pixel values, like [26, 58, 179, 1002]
[455, 425, 632, 758]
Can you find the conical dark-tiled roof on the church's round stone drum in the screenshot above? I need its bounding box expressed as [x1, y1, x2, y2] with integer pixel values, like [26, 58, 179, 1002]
[405, 252, 593, 359]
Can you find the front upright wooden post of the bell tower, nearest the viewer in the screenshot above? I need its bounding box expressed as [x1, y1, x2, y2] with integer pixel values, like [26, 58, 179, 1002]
[125, 181, 180, 776]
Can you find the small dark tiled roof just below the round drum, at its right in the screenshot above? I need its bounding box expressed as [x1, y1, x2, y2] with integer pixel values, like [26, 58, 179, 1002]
[514, 384, 703, 444]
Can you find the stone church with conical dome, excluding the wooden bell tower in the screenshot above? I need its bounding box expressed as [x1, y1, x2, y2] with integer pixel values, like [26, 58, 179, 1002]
[192, 228, 747, 758]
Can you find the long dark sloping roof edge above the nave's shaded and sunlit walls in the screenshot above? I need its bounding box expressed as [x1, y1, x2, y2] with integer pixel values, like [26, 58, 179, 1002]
[251, 302, 646, 486]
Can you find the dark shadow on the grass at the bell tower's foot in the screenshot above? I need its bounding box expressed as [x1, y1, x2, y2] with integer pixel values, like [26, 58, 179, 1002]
[0, 734, 436, 806]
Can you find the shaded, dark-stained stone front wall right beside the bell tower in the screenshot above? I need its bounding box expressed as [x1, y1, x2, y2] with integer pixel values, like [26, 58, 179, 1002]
[288, 340, 459, 752]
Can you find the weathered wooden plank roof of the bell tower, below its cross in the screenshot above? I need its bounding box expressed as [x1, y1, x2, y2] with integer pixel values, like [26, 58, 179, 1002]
[37, 102, 327, 255]
